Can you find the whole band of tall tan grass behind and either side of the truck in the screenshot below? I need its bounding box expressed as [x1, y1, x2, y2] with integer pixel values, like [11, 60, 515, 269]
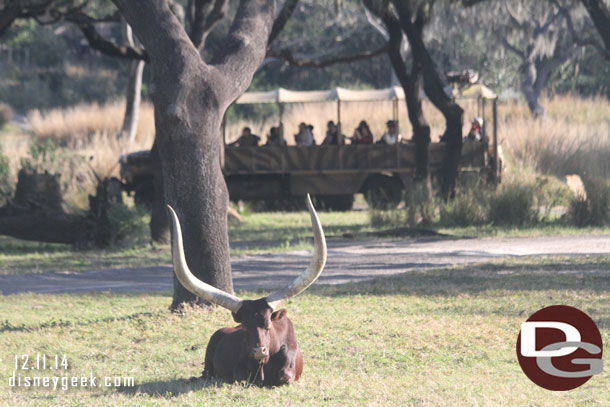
[5, 95, 610, 207]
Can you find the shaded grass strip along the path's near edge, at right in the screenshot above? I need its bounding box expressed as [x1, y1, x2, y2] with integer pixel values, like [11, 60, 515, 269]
[310, 256, 610, 296]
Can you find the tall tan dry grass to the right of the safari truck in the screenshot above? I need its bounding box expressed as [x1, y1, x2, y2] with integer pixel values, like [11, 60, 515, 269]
[499, 95, 610, 178]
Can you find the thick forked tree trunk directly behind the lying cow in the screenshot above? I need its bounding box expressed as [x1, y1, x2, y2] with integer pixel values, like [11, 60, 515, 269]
[113, 0, 275, 309]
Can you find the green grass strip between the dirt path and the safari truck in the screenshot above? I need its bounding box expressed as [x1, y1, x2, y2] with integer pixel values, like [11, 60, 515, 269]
[0, 207, 610, 275]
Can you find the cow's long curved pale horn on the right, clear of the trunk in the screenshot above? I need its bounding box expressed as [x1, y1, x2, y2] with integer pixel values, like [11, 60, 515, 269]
[266, 194, 326, 310]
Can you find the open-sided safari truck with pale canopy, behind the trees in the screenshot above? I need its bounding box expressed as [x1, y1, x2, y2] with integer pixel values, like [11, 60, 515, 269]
[120, 84, 502, 210]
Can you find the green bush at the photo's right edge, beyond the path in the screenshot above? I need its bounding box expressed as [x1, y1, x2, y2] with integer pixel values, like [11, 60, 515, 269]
[567, 178, 610, 227]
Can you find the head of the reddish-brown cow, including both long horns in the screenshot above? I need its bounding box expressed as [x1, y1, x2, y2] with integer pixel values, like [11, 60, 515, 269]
[168, 195, 326, 363]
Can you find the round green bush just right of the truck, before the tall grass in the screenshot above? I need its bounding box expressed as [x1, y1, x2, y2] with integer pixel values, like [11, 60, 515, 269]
[488, 183, 538, 226]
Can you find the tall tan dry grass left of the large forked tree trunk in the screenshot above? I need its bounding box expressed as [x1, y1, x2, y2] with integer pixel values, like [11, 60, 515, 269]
[2, 101, 155, 208]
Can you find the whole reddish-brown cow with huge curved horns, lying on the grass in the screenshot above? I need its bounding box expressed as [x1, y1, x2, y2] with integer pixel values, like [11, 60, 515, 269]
[168, 196, 326, 386]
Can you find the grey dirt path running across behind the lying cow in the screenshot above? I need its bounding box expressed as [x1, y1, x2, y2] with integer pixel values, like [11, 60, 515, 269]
[0, 236, 610, 295]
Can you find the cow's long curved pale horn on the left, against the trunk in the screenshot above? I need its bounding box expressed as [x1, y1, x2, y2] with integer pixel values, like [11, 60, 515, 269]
[167, 205, 241, 312]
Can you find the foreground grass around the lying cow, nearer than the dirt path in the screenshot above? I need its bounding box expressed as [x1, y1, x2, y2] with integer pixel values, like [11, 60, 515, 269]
[0, 256, 610, 406]
